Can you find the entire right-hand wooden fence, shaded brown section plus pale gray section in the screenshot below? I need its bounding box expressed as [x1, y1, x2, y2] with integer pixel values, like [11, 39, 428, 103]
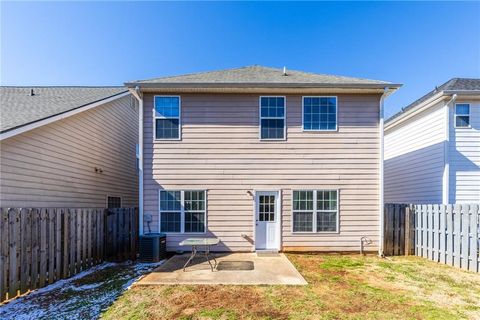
[384, 204, 480, 272]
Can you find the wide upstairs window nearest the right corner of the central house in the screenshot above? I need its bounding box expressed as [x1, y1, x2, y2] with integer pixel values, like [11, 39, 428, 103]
[303, 97, 337, 131]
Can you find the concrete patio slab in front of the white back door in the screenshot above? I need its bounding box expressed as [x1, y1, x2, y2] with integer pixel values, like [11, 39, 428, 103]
[135, 253, 307, 286]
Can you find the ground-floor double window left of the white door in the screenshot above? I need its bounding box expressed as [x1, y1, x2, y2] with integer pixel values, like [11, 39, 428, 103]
[160, 190, 206, 233]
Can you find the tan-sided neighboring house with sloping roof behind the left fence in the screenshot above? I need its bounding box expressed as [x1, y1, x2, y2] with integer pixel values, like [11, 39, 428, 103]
[0, 87, 138, 208]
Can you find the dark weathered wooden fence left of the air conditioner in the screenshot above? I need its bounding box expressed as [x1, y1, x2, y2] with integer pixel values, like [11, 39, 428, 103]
[0, 208, 138, 302]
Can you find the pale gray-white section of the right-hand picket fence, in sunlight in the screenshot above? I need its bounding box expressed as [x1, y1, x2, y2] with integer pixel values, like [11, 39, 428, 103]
[412, 204, 480, 272]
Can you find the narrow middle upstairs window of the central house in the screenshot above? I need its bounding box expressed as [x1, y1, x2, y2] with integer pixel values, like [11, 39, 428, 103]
[260, 97, 285, 140]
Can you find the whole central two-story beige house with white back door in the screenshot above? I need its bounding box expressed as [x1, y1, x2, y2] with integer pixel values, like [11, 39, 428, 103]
[126, 66, 399, 251]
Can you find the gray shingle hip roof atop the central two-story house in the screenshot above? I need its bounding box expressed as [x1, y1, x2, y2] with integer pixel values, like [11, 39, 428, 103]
[125, 65, 400, 87]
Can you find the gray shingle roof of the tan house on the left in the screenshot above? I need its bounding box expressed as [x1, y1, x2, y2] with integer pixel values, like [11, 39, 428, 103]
[0, 87, 127, 133]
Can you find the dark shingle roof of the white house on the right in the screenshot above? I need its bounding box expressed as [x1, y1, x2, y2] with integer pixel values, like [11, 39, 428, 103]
[385, 78, 480, 124]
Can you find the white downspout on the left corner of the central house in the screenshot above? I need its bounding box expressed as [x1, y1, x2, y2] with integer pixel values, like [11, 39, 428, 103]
[129, 86, 144, 235]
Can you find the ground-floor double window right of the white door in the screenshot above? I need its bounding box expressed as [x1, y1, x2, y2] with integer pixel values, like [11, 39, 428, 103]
[292, 190, 339, 232]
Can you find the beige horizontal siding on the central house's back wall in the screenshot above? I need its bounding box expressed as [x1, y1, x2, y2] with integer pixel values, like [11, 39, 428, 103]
[144, 92, 380, 251]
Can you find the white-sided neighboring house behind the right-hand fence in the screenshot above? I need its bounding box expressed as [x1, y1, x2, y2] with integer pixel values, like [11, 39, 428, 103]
[385, 78, 480, 204]
